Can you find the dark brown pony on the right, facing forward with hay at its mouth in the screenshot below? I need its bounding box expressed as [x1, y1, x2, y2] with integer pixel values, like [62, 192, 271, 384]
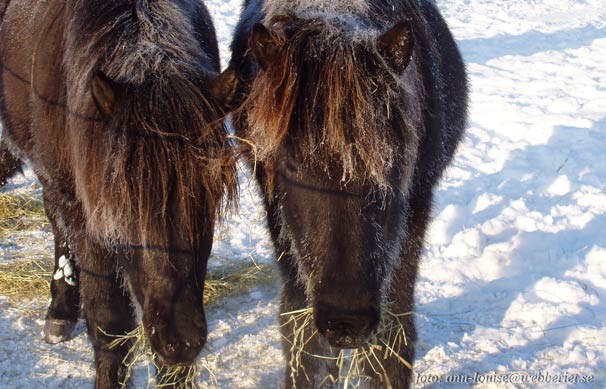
[225, 0, 467, 388]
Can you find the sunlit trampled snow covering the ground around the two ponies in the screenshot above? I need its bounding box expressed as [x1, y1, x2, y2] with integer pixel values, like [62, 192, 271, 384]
[0, 0, 606, 388]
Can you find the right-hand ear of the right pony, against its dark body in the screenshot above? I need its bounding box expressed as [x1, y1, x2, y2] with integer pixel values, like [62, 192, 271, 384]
[378, 20, 414, 74]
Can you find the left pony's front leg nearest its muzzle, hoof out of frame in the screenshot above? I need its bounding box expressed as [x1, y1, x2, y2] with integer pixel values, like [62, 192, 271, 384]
[79, 242, 136, 389]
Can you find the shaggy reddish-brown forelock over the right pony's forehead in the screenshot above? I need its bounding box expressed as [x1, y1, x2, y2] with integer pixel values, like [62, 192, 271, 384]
[243, 15, 423, 191]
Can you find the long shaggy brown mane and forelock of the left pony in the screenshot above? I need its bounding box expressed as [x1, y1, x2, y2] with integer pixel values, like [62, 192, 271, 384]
[64, 0, 236, 244]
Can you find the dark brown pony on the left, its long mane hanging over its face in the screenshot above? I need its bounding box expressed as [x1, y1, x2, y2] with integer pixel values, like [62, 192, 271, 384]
[0, 0, 235, 387]
